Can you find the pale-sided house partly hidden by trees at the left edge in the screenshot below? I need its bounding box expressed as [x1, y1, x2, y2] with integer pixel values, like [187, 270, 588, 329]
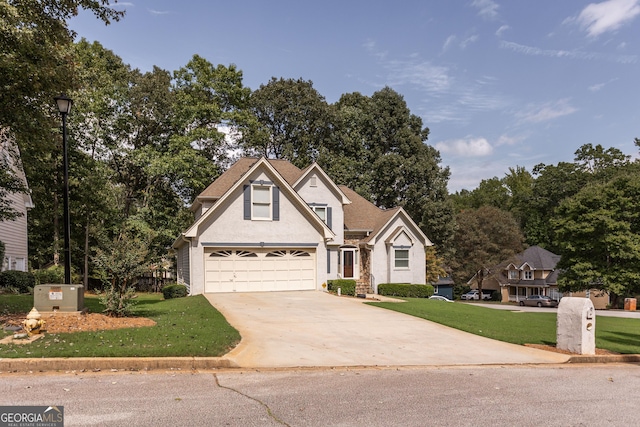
[0, 130, 33, 271]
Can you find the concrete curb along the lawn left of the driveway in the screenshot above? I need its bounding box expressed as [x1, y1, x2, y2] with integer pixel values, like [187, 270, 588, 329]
[0, 357, 238, 372]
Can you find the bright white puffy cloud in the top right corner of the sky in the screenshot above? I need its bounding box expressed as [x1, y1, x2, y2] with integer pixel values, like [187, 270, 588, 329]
[564, 0, 640, 37]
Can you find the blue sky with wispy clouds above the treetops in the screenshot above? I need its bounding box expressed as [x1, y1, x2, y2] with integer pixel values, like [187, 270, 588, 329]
[69, 0, 640, 192]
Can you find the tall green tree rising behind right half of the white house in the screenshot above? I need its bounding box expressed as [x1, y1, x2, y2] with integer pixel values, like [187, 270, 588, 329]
[318, 87, 453, 253]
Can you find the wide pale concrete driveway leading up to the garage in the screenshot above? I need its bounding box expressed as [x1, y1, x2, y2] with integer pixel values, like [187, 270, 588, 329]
[206, 291, 569, 368]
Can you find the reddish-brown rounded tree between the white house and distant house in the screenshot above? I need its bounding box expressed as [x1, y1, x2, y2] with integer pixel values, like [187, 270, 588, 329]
[450, 206, 524, 292]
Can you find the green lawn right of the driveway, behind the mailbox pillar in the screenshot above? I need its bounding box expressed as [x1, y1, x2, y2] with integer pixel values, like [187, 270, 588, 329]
[369, 298, 640, 354]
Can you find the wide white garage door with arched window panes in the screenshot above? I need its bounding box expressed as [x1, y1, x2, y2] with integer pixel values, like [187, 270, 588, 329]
[204, 249, 316, 293]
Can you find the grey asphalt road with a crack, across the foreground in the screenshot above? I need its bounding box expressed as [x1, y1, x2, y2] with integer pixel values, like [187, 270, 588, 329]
[0, 364, 640, 427]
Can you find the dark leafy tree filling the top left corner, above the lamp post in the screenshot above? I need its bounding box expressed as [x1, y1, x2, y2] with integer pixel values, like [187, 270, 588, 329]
[0, 0, 124, 148]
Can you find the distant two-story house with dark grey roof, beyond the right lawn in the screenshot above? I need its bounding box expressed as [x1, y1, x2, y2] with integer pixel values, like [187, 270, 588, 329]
[468, 246, 609, 309]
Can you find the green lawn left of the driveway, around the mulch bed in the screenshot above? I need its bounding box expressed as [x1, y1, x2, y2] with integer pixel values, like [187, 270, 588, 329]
[0, 294, 240, 358]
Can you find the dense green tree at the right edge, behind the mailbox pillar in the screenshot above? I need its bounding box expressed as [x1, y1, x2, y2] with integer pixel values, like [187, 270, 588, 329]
[553, 169, 640, 304]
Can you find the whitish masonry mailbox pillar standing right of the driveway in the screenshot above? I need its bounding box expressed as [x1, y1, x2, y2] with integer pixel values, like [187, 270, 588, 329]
[556, 297, 596, 354]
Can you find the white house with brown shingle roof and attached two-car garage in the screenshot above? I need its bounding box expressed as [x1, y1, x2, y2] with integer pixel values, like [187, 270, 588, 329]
[173, 157, 432, 295]
